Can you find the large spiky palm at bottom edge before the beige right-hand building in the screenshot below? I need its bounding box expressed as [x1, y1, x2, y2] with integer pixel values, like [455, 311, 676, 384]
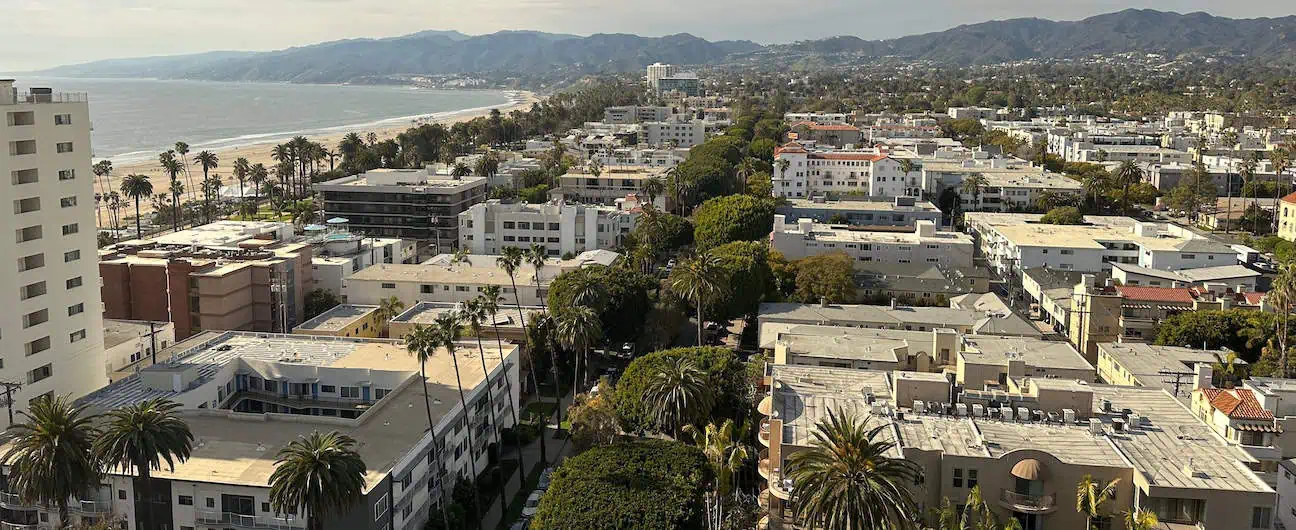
[787, 409, 923, 530]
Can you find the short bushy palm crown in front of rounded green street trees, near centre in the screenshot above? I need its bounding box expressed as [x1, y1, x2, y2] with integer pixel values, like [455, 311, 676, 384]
[644, 356, 715, 439]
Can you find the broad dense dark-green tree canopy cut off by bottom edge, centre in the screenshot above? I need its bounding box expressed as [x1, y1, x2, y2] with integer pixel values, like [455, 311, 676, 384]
[530, 439, 712, 530]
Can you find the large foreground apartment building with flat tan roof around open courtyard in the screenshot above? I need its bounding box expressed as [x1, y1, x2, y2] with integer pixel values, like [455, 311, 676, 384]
[41, 332, 518, 530]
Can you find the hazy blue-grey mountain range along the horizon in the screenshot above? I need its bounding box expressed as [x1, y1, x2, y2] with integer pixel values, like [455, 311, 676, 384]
[41, 9, 1296, 83]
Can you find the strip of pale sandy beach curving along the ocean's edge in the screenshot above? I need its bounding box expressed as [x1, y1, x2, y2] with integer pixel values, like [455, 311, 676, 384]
[95, 91, 540, 222]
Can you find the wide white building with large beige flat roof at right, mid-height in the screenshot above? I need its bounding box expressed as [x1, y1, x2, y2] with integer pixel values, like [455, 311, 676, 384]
[964, 213, 1238, 275]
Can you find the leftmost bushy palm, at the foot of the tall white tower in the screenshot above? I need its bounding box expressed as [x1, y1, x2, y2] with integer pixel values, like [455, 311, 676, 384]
[0, 395, 101, 524]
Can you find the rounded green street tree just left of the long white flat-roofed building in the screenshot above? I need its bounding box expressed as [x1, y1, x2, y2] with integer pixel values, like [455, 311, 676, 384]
[693, 196, 774, 251]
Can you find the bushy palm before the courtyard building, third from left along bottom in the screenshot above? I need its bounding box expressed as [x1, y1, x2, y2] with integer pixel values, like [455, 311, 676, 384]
[270, 430, 365, 530]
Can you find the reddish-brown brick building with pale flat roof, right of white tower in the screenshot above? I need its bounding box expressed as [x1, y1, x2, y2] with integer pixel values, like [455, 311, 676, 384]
[98, 220, 315, 340]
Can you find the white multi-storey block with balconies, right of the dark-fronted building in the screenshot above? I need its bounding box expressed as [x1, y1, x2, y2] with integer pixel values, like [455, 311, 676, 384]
[459, 198, 640, 255]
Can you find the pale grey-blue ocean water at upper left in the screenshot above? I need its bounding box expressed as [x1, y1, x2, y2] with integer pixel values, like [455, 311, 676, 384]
[11, 76, 511, 163]
